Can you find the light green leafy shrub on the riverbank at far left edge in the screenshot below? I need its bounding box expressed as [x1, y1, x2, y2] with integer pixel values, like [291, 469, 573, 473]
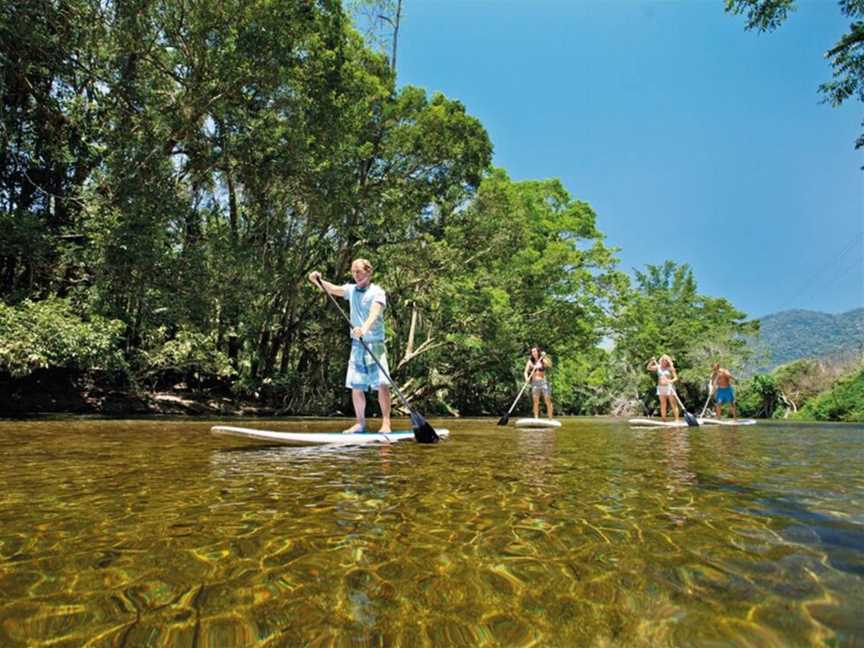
[0, 297, 125, 378]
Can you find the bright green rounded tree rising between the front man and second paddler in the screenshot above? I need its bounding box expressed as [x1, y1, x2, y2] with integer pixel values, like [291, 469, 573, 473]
[370, 170, 622, 414]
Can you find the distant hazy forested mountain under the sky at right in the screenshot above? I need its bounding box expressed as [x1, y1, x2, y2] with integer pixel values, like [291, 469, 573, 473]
[759, 308, 864, 371]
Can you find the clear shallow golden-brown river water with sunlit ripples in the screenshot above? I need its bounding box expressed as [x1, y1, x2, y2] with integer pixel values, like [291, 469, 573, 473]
[0, 419, 864, 648]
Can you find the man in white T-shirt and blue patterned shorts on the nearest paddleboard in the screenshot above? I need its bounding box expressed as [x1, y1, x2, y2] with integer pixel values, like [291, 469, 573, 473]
[309, 259, 391, 434]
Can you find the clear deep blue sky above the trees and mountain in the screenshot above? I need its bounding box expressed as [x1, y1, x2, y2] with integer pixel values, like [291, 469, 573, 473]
[397, 0, 864, 317]
